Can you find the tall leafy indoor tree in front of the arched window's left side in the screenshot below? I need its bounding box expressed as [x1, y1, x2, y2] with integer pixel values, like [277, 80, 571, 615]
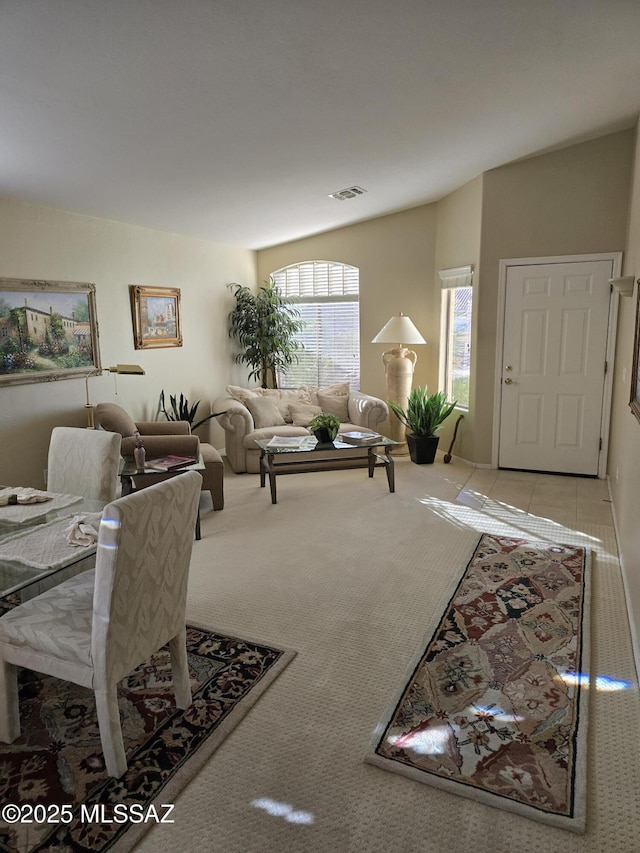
[229, 278, 302, 388]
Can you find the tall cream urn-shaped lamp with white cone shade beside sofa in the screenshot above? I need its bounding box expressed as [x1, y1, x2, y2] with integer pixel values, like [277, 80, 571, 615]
[371, 313, 426, 453]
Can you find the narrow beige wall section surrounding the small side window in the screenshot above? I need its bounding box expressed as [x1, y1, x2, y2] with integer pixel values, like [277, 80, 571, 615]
[432, 176, 483, 459]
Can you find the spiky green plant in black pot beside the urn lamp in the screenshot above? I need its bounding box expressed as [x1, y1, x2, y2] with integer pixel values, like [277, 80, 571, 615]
[387, 385, 457, 465]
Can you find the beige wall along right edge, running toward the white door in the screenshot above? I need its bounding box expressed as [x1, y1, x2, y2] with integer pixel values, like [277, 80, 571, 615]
[609, 123, 640, 668]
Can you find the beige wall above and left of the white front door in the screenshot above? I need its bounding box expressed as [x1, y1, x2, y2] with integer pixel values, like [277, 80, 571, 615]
[474, 130, 633, 464]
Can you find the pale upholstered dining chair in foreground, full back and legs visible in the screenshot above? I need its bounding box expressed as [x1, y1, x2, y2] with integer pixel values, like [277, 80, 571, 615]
[0, 471, 202, 776]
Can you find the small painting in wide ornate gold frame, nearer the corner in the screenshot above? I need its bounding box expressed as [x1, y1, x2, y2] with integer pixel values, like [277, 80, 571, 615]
[129, 284, 182, 349]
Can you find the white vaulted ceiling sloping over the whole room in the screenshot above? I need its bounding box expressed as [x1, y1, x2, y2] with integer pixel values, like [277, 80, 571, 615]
[0, 0, 640, 248]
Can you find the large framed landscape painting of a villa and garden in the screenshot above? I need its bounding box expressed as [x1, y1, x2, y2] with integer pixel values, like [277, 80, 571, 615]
[0, 278, 100, 385]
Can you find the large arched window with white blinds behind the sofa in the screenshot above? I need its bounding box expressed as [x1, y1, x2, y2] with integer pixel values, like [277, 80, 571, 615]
[271, 261, 360, 390]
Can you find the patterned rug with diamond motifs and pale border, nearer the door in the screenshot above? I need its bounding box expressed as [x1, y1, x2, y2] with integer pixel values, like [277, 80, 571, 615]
[367, 534, 590, 832]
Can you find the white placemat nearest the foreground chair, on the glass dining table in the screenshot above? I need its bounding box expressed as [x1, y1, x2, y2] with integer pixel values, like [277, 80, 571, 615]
[0, 512, 102, 569]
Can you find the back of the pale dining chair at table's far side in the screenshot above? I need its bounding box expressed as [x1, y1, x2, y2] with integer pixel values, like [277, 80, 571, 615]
[47, 427, 122, 501]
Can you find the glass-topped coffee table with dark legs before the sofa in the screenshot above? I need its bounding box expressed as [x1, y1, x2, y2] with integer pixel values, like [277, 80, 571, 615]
[256, 435, 401, 504]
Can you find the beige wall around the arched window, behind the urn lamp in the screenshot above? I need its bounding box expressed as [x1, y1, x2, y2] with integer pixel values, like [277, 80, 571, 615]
[258, 201, 439, 410]
